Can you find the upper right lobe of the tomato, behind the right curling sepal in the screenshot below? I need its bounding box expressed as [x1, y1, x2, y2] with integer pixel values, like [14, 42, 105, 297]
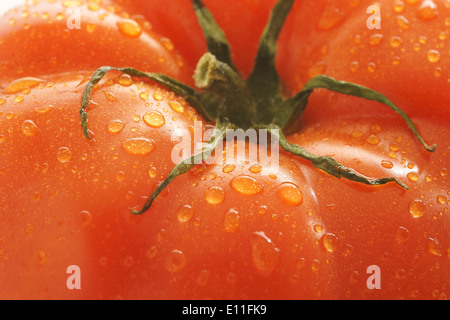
[278, 0, 450, 124]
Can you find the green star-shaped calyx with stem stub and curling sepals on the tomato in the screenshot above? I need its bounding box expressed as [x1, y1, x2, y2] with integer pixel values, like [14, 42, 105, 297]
[80, 0, 436, 214]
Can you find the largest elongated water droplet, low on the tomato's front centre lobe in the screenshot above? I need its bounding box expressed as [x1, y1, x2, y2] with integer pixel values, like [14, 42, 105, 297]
[250, 232, 280, 276]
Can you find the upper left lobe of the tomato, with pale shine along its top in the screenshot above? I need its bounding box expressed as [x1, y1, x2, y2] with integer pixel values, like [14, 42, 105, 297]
[0, 1, 193, 83]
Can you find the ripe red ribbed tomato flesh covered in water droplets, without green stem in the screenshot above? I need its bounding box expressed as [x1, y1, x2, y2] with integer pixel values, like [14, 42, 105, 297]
[0, 0, 450, 299]
